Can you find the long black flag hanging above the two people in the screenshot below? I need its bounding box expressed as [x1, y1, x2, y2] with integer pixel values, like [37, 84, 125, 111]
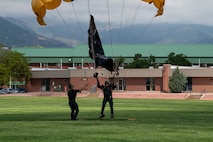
[88, 15, 114, 72]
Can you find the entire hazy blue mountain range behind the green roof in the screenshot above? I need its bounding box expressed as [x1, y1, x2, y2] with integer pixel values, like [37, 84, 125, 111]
[0, 17, 213, 47]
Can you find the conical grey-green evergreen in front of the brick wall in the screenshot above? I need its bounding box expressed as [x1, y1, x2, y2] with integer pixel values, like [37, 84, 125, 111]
[169, 68, 187, 93]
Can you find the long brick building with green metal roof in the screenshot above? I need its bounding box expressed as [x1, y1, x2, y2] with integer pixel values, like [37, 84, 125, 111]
[13, 45, 213, 92]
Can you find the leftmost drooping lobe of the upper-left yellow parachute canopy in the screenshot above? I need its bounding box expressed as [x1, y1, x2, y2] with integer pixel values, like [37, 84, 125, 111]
[32, 0, 46, 25]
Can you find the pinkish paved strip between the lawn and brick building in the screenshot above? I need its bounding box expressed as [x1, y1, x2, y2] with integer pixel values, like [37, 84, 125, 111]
[0, 91, 213, 100]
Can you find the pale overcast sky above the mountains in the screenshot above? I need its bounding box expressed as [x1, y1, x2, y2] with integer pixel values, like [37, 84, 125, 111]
[0, 0, 213, 26]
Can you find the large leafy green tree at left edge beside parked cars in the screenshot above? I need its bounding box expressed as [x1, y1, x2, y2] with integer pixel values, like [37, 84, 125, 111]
[0, 50, 31, 85]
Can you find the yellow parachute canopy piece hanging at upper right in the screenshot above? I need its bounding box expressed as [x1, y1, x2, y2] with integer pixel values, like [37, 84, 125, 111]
[143, 0, 165, 16]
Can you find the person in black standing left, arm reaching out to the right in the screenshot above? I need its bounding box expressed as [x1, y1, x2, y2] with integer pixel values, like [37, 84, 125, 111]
[68, 84, 87, 120]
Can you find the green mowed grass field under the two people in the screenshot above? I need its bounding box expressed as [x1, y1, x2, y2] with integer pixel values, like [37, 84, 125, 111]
[0, 97, 213, 142]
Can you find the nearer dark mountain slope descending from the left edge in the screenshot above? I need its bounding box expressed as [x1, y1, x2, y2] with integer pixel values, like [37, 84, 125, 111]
[0, 17, 66, 47]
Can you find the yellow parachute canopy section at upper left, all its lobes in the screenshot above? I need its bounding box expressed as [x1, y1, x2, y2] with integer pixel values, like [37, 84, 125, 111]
[31, 0, 74, 25]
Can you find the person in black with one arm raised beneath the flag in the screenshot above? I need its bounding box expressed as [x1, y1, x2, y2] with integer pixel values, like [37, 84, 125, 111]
[94, 73, 115, 119]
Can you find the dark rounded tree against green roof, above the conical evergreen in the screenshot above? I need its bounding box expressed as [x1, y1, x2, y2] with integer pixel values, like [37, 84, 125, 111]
[166, 52, 191, 66]
